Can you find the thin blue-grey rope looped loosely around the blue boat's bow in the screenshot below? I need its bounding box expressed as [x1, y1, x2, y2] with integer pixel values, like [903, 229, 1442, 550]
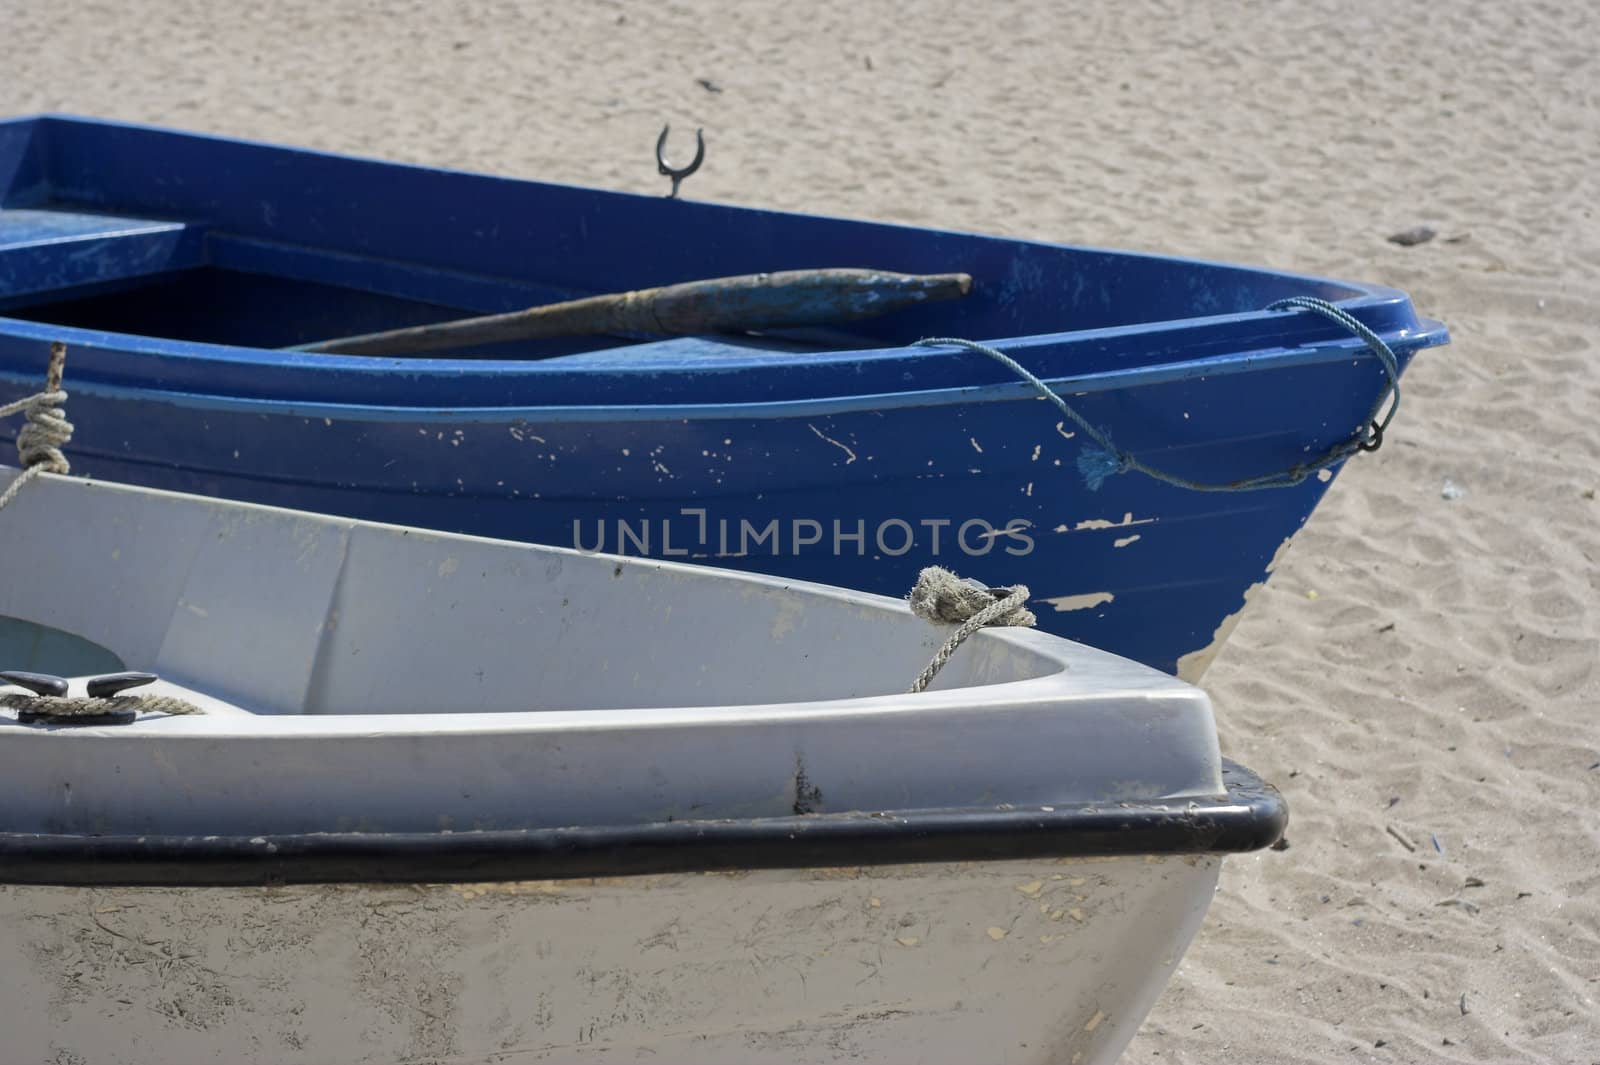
[917, 296, 1400, 493]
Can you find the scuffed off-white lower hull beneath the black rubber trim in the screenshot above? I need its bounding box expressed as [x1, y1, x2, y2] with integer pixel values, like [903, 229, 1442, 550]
[0, 856, 1221, 1065]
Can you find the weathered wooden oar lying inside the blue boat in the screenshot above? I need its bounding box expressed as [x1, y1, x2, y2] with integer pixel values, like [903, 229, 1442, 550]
[291, 269, 973, 355]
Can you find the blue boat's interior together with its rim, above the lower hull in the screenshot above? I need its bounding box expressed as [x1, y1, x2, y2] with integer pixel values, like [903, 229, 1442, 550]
[0, 117, 1440, 406]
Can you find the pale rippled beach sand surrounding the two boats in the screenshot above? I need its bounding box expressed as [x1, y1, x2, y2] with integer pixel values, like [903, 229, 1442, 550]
[0, 0, 1600, 1062]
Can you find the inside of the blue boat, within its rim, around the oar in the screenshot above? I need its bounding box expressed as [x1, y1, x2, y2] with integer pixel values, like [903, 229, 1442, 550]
[0, 117, 1363, 369]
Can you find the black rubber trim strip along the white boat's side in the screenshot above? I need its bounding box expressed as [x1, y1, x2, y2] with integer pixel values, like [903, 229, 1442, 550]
[0, 761, 1288, 888]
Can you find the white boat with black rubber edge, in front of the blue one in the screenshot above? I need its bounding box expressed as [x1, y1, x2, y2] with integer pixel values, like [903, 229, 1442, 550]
[0, 470, 1285, 1065]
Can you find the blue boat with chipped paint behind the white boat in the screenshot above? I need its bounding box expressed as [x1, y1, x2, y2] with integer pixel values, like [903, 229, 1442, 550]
[0, 117, 1446, 676]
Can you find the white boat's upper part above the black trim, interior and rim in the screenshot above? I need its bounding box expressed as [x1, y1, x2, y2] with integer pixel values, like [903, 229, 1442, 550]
[0, 470, 1221, 833]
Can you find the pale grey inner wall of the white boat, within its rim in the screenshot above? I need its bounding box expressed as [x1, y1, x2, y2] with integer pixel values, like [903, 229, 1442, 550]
[0, 470, 1088, 715]
